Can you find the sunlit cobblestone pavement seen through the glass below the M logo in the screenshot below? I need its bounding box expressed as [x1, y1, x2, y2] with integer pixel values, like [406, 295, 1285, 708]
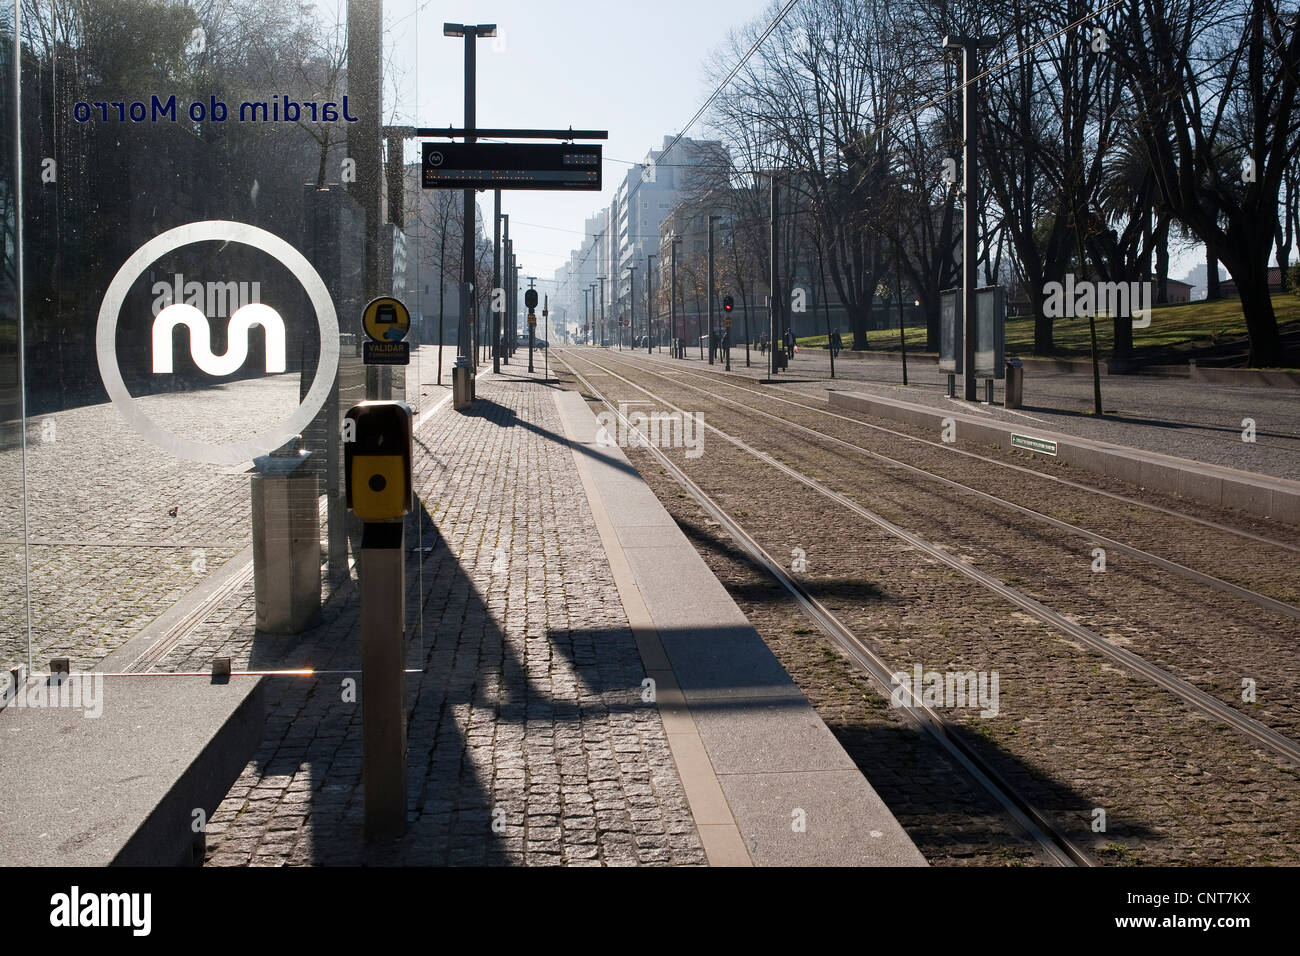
[0, 346, 455, 693]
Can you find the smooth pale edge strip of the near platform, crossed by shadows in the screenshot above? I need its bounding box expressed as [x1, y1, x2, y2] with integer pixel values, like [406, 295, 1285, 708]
[554, 392, 926, 866]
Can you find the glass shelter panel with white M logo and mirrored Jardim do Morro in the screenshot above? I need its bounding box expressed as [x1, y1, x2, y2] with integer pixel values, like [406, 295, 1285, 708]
[0, 0, 426, 697]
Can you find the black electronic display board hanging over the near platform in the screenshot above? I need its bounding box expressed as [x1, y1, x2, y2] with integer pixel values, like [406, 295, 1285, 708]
[420, 143, 601, 191]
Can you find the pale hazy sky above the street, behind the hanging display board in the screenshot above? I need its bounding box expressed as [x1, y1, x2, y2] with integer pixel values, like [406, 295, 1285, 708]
[408, 0, 770, 287]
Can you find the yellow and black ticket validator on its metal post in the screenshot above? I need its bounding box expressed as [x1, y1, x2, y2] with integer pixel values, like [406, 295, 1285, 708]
[343, 402, 415, 840]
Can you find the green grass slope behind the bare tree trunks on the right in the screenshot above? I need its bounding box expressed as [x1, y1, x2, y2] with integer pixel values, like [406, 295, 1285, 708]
[798, 295, 1300, 364]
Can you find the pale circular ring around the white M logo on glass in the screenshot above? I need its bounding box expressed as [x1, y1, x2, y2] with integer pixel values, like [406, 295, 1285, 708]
[95, 220, 338, 464]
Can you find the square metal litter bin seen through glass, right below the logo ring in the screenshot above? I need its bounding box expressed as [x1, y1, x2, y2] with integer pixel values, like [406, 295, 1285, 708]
[250, 436, 321, 635]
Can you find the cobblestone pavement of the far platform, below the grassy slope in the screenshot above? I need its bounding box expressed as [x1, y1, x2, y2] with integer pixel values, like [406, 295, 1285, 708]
[660, 347, 1300, 480]
